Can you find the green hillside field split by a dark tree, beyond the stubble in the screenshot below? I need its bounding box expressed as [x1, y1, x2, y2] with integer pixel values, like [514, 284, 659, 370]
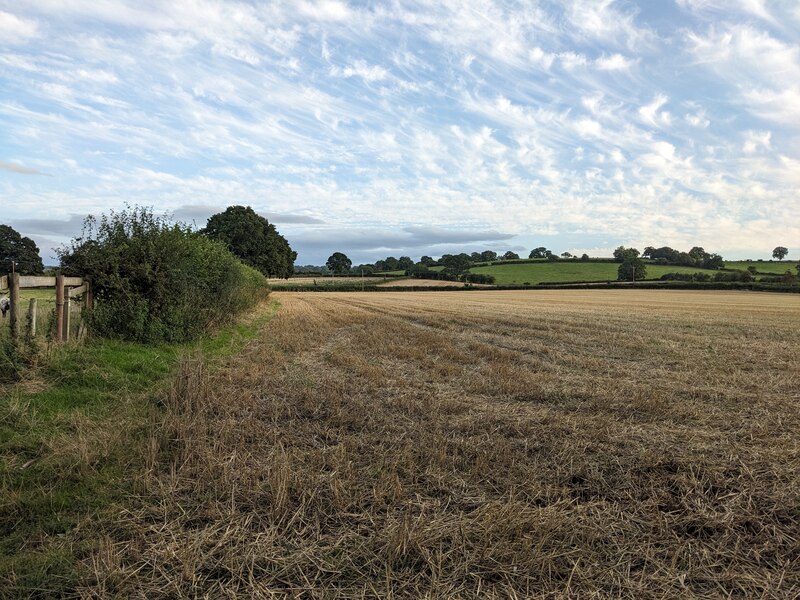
[470, 260, 714, 285]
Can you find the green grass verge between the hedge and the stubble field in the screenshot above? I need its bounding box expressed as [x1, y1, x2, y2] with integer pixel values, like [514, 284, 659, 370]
[0, 303, 277, 597]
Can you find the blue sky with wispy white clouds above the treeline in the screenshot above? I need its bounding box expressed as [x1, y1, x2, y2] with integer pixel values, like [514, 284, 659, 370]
[0, 0, 800, 264]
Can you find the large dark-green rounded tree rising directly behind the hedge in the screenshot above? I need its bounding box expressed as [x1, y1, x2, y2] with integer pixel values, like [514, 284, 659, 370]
[201, 206, 297, 279]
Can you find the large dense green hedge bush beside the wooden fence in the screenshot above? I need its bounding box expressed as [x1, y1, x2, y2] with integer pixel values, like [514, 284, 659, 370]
[59, 207, 268, 342]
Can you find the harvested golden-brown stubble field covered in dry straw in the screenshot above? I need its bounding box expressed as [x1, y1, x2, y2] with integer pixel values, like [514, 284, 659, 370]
[83, 291, 800, 598]
